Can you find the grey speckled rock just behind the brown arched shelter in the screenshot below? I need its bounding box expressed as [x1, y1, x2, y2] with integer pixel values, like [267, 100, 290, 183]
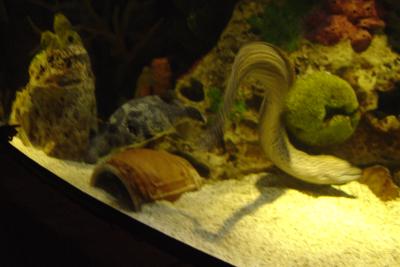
[85, 95, 205, 163]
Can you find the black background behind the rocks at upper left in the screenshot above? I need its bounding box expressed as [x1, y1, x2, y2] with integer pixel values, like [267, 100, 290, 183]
[0, 0, 237, 120]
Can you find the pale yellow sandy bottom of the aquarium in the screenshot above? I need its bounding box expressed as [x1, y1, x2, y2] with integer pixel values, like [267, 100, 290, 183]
[12, 138, 400, 266]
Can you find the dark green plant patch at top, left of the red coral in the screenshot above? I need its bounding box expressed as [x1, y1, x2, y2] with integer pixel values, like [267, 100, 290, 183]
[248, 0, 318, 52]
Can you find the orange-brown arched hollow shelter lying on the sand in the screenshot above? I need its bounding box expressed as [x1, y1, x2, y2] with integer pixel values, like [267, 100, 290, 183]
[91, 148, 202, 210]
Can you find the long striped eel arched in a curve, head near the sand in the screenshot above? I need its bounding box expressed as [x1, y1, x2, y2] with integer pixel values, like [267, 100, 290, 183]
[214, 42, 362, 184]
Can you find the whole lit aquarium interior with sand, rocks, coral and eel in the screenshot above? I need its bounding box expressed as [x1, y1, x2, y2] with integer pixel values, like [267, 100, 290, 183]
[0, 0, 400, 266]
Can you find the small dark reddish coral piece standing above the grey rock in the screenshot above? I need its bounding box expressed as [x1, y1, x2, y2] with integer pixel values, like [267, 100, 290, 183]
[136, 57, 172, 97]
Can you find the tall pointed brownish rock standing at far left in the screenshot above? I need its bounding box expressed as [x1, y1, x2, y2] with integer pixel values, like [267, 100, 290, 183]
[10, 14, 97, 160]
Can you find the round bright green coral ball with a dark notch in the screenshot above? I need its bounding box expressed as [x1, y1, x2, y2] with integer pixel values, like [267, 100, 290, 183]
[284, 72, 360, 146]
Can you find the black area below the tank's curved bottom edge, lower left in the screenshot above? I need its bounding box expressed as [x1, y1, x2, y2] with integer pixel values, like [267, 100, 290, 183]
[0, 143, 227, 267]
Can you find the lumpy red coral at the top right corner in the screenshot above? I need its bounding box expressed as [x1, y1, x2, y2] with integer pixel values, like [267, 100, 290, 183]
[307, 0, 385, 52]
